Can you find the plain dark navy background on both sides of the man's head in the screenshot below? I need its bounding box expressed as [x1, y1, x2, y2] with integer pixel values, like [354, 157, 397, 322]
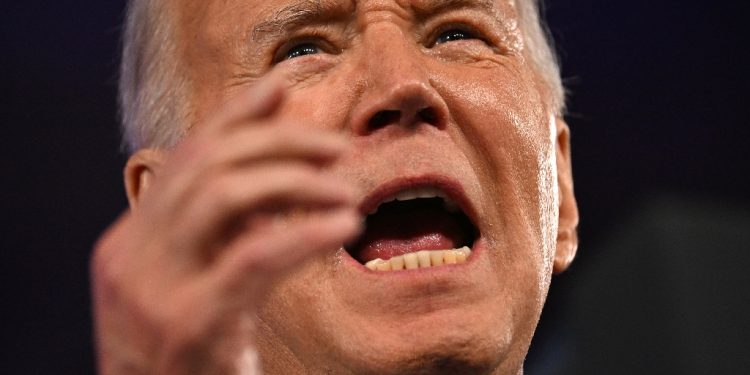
[0, 0, 750, 375]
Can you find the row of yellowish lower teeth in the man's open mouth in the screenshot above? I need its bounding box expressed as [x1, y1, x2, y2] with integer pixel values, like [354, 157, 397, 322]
[365, 246, 471, 271]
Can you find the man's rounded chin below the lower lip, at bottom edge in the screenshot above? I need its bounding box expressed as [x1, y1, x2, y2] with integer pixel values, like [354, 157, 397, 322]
[326, 309, 530, 375]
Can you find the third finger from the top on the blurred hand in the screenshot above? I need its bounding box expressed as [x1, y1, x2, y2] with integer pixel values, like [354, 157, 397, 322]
[175, 163, 354, 251]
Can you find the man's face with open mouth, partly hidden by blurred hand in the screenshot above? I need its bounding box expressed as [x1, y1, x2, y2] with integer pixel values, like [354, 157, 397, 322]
[174, 0, 576, 373]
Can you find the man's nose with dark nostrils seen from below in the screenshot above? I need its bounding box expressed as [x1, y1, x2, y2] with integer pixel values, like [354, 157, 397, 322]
[352, 27, 448, 135]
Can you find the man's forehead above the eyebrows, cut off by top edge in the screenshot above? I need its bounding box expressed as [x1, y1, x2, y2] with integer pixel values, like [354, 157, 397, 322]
[172, 0, 517, 56]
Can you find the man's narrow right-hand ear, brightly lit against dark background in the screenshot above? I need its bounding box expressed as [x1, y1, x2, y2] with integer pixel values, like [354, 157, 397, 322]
[553, 117, 578, 274]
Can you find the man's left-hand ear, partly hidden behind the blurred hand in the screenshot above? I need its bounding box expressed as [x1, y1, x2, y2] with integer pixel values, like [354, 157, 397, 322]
[123, 148, 166, 209]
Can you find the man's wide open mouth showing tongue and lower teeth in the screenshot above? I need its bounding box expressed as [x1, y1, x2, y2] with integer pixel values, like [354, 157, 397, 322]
[345, 186, 478, 271]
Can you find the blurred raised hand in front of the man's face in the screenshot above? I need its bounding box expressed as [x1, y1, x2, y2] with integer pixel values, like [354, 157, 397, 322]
[92, 78, 360, 374]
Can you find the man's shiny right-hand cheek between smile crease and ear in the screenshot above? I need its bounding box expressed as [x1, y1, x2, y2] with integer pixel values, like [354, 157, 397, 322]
[441, 67, 554, 268]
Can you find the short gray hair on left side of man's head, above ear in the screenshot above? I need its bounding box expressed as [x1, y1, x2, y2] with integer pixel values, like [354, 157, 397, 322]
[119, 0, 190, 152]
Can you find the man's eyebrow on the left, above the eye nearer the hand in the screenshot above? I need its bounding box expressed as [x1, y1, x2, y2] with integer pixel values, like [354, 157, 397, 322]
[251, 0, 354, 43]
